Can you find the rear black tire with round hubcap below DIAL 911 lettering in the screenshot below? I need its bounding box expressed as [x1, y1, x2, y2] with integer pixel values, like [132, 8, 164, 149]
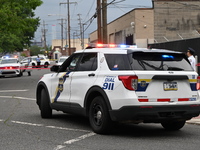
[89, 96, 112, 134]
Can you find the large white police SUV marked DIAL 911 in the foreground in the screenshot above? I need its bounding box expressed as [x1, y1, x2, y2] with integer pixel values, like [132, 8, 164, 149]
[36, 45, 200, 134]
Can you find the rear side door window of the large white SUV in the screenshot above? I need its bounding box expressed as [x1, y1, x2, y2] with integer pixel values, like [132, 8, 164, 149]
[77, 53, 97, 71]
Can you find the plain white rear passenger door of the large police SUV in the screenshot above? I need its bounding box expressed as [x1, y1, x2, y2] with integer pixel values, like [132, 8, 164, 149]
[70, 52, 98, 107]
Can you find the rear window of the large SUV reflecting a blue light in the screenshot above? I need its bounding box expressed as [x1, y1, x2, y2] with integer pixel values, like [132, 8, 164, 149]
[131, 52, 193, 71]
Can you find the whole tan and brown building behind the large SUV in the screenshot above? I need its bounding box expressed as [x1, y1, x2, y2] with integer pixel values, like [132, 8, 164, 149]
[90, 0, 200, 47]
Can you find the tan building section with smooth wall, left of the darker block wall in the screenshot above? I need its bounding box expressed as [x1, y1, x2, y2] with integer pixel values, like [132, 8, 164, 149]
[89, 8, 154, 47]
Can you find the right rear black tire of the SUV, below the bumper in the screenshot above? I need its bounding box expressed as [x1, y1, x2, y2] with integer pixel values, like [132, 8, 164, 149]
[161, 120, 185, 131]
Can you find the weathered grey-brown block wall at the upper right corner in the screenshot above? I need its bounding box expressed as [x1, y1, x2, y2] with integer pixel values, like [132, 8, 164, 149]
[153, 0, 200, 43]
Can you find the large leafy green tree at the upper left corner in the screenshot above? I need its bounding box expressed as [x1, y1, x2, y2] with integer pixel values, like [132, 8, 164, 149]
[0, 0, 42, 52]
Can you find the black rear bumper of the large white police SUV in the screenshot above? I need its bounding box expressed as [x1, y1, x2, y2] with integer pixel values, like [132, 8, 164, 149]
[109, 104, 200, 123]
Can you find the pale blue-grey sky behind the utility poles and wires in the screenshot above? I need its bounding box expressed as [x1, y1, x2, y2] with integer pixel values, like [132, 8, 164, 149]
[34, 0, 152, 45]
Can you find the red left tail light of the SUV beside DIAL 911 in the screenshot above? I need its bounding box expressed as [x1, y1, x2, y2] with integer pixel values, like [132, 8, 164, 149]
[118, 75, 138, 91]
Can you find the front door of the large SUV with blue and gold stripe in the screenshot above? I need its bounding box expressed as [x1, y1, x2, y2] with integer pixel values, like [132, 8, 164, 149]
[51, 54, 81, 102]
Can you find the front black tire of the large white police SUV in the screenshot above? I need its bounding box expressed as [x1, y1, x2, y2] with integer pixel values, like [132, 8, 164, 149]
[40, 89, 52, 118]
